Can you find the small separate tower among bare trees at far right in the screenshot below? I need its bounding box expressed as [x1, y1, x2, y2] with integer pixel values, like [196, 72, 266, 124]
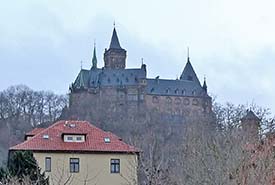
[241, 110, 261, 140]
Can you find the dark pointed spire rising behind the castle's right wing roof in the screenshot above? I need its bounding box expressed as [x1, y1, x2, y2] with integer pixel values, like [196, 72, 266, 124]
[180, 47, 200, 84]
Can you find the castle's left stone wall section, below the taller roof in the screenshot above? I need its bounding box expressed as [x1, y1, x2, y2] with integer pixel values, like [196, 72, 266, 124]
[70, 86, 145, 121]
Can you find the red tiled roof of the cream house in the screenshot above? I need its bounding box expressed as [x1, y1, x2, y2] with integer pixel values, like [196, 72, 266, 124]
[10, 121, 139, 153]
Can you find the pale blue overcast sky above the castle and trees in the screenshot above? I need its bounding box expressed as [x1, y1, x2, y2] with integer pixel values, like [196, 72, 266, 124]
[0, 0, 275, 113]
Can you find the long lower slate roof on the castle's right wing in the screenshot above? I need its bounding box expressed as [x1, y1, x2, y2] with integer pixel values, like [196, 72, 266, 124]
[146, 78, 206, 96]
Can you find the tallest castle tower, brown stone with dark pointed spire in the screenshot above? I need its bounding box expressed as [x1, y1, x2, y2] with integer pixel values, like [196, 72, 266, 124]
[104, 27, 126, 69]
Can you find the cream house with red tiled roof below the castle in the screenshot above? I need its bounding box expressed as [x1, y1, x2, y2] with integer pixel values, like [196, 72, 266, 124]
[10, 121, 139, 185]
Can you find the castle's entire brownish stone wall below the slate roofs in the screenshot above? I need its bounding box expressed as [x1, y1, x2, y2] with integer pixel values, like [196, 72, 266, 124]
[69, 85, 212, 126]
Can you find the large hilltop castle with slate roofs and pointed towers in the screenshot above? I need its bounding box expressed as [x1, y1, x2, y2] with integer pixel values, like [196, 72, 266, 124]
[69, 27, 212, 121]
